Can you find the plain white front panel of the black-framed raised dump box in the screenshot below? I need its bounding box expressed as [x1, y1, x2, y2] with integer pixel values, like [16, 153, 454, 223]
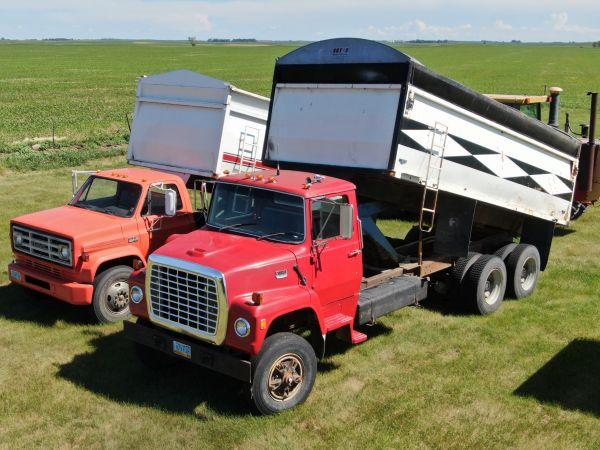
[268, 83, 401, 170]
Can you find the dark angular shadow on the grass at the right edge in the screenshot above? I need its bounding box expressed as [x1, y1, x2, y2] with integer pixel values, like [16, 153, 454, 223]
[514, 339, 600, 416]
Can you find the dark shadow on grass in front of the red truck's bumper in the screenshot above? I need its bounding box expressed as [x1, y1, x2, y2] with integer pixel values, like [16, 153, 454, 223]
[58, 332, 253, 420]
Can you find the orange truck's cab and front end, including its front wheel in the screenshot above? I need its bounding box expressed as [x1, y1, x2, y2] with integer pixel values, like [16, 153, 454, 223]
[8, 168, 196, 322]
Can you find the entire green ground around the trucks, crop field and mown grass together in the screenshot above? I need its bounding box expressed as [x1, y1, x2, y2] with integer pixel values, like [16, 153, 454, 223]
[0, 43, 600, 449]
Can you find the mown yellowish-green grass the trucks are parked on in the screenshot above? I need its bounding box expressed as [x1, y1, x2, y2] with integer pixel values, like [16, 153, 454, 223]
[0, 158, 600, 448]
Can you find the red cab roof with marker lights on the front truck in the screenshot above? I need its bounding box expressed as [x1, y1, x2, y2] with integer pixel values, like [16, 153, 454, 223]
[219, 169, 356, 198]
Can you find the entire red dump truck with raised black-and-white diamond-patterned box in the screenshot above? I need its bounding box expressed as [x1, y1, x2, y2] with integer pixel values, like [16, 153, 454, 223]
[124, 39, 580, 414]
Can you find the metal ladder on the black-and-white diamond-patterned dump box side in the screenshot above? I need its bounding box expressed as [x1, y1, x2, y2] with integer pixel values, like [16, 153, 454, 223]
[419, 122, 448, 266]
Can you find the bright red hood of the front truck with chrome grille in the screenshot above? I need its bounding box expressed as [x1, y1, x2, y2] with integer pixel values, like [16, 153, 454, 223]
[155, 229, 301, 298]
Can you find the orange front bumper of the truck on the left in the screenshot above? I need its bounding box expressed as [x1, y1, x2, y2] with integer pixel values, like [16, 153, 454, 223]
[8, 262, 94, 305]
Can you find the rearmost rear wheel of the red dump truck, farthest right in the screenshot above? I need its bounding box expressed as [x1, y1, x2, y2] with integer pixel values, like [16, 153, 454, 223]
[506, 244, 540, 299]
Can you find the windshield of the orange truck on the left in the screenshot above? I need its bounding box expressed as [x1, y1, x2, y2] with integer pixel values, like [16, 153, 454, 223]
[70, 177, 142, 217]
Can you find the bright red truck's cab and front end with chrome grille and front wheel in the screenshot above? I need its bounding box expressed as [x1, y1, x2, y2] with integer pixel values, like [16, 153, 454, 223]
[125, 170, 366, 413]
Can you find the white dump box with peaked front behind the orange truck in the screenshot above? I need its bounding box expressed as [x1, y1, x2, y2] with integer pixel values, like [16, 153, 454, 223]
[128, 70, 269, 177]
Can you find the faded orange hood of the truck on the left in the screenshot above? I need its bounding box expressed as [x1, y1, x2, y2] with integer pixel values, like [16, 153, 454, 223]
[12, 205, 128, 245]
